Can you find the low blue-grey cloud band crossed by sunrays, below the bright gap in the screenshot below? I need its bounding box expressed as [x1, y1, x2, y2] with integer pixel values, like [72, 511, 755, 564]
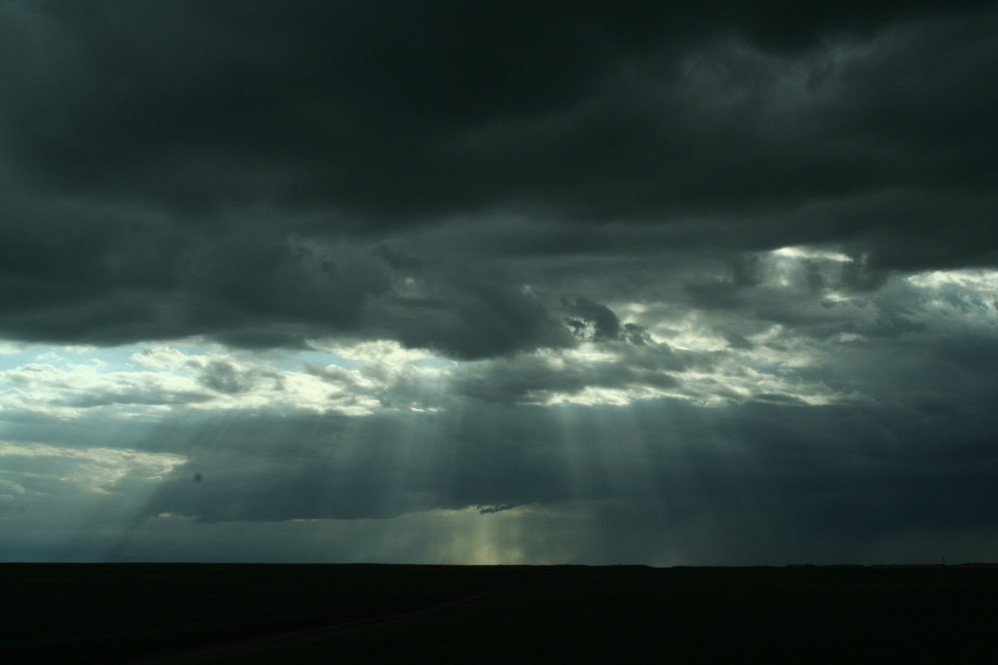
[82, 400, 998, 544]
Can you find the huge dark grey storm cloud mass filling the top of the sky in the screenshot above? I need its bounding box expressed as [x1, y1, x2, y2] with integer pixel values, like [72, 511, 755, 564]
[0, 1, 998, 358]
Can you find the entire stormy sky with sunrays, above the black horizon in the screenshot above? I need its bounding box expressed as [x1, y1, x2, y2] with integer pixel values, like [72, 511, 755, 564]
[0, 0, 998, 566]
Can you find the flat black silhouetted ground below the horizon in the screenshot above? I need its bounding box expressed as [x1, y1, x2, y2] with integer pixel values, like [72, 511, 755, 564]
[0, 564, 998, 664]
